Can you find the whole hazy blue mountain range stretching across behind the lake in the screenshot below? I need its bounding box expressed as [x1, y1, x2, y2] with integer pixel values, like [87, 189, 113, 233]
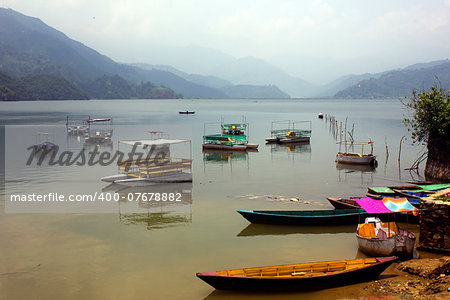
[0, 8, 450, 98]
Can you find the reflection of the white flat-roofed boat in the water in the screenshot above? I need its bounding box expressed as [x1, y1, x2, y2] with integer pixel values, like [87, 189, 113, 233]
[102, 182, 192, 230]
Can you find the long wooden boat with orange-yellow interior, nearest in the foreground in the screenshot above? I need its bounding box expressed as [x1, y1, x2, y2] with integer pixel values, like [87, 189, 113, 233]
[196, 256, 397, 291]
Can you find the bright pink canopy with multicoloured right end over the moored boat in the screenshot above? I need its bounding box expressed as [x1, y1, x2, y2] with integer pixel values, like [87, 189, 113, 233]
[355, 197, 418, 213]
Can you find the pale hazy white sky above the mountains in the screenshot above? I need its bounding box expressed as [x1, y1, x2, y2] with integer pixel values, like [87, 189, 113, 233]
[0, 0, 450, 82]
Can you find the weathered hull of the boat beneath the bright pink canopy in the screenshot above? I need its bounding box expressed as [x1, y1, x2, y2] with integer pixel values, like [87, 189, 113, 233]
[356, 229, 416, 258]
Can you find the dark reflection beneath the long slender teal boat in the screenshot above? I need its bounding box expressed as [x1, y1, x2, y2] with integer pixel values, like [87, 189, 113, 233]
[237, 224, 355, 237]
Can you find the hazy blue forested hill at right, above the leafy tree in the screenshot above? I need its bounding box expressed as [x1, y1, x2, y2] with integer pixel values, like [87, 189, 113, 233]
[335, 60, 450, 98]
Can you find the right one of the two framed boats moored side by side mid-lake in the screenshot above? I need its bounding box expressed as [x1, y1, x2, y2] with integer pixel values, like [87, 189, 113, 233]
[266, 120, 311, 144]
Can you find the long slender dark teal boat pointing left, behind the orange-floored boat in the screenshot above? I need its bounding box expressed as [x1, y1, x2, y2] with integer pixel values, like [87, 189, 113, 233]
[238, 209, 387, 225]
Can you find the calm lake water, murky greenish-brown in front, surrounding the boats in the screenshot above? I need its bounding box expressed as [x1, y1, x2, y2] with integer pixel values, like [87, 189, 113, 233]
[0, 99, 424, 299]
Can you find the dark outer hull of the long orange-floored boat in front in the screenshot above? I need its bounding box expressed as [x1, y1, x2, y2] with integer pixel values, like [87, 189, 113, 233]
[196, 257, 397, 291]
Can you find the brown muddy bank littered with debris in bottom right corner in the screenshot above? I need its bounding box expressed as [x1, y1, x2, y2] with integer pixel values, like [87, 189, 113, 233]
[363, 256, 450, 299]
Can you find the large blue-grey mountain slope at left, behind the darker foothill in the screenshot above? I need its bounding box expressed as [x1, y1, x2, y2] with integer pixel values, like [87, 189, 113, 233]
[0, 8, 226, 98]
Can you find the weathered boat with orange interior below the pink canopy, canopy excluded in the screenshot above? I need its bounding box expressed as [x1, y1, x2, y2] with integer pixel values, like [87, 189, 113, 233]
[356, 218, 416, 258]
